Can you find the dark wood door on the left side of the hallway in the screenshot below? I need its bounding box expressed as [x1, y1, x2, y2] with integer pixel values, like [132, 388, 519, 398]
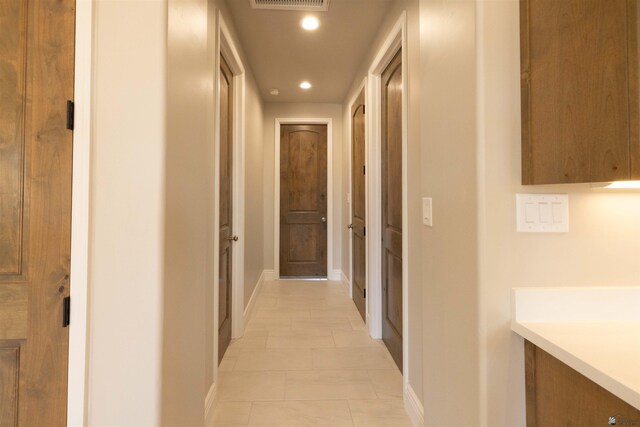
[218, 57, 235, 362]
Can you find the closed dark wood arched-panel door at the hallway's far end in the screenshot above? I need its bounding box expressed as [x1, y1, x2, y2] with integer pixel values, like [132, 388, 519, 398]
[280, 125, 327, 277]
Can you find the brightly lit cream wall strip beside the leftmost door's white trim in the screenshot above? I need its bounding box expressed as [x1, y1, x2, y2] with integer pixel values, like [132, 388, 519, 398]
[87, 0, 167, 426]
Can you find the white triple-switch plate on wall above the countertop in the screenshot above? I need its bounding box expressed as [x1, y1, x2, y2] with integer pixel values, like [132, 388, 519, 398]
[516, 194, 569, 233]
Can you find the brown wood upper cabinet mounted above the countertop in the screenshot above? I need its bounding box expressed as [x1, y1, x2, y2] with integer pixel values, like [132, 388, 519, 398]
[520, 0, 640, 184]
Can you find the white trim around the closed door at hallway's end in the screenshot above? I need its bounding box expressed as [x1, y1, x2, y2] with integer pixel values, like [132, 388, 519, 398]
[273, 118, 341, 280]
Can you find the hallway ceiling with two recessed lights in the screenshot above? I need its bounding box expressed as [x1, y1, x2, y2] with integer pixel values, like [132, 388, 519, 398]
[226, 0, 394, 103]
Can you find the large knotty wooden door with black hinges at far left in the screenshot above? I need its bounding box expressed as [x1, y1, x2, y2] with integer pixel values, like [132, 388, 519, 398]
[0, 0, 75, 426]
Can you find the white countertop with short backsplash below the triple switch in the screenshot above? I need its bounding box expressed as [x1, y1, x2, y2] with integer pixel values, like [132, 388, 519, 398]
[511, 287, 640, 409]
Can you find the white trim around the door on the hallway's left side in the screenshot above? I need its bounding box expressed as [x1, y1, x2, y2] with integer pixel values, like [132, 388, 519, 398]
[211, 10, 246, 383]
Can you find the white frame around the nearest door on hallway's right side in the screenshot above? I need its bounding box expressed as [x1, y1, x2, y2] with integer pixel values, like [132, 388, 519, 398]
[365, 11, 410, 378]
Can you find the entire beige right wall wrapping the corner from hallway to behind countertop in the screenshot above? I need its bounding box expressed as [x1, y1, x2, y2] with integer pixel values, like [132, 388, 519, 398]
[421, 0, 640, 427]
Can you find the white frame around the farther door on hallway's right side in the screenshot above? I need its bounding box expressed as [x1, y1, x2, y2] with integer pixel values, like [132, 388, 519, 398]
[346, 77, 369, 304]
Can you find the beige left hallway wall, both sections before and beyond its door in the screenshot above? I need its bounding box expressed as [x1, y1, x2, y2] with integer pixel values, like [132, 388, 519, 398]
[162, 0, 263, 425]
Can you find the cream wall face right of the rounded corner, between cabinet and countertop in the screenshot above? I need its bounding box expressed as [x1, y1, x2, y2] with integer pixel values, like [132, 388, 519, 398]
[477, 0, 640, 427]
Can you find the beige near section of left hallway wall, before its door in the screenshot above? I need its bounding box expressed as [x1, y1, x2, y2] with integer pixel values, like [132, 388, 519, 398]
[161, 0, 214, 426]
